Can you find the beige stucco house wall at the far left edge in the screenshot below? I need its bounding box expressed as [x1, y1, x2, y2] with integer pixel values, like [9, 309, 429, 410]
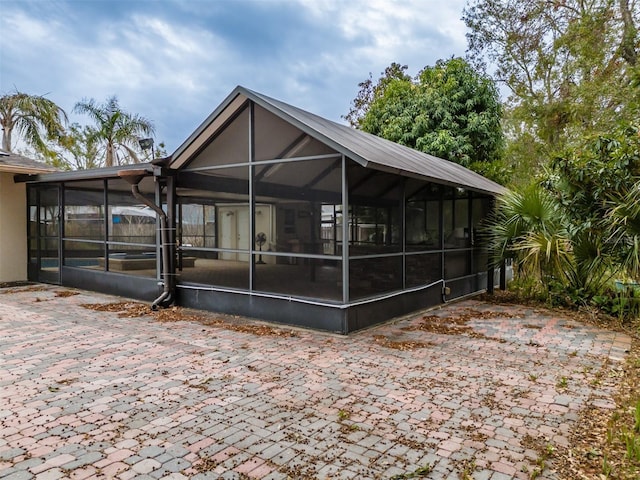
[0, 172, 27, 282]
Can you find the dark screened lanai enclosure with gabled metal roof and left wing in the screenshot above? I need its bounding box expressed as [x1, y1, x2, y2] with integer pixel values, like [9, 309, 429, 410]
[23, 87, 503, 333]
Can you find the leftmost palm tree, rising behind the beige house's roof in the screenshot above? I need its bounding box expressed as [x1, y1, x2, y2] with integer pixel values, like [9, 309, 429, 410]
[0, 90, 67, 154]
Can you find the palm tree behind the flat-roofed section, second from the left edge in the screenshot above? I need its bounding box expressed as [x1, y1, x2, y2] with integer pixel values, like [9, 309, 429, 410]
[73, 96, 155, 167]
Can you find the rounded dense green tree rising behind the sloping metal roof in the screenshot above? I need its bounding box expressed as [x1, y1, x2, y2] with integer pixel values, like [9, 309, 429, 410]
[347, 58, 504, 180]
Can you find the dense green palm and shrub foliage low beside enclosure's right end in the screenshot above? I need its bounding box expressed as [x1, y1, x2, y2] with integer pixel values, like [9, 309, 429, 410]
[487, 124, 640, 316]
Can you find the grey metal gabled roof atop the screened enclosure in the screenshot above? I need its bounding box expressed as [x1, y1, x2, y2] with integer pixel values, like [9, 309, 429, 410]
[171, 86, 506, 194]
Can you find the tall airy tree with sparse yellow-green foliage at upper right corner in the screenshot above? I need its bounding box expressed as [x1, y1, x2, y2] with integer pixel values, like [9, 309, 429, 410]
[463, 0, 640, 181]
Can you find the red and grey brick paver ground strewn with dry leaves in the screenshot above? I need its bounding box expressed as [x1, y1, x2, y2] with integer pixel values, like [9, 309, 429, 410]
[0, 286, 630, 480]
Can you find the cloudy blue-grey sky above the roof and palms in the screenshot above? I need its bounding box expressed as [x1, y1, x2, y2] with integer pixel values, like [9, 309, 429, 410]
[0, 0, 466, 153]
